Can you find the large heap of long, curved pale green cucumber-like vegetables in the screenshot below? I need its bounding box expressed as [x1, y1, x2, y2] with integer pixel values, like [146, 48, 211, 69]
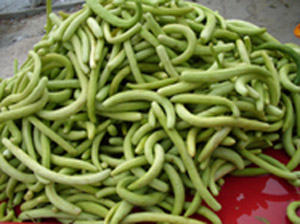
[0, 0, 300, 224]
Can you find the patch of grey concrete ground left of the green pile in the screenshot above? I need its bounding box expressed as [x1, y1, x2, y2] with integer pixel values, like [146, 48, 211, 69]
[0, 0, 81, 78]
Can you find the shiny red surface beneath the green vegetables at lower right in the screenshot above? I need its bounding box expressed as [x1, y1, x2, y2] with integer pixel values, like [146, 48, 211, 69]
[0, 150, 300, 224]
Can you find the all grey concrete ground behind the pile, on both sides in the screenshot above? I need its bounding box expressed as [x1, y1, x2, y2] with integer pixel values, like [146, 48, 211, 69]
[0, 0, 300, 77]
